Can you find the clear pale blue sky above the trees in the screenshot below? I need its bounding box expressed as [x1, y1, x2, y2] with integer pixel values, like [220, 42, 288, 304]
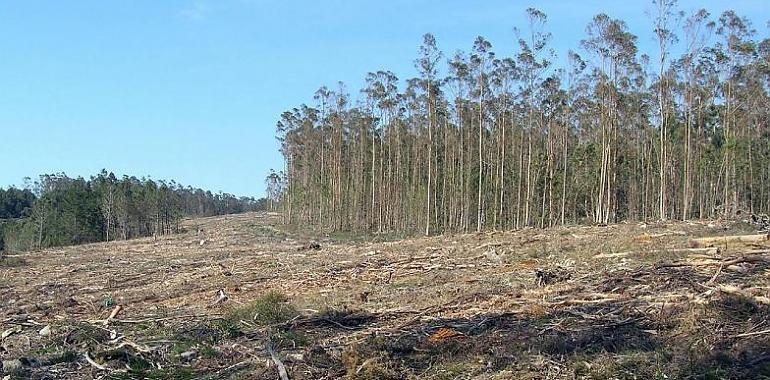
[0, 0, 770, 196]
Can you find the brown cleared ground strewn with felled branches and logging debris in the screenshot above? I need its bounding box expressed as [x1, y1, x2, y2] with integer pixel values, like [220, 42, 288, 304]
[0, 213, 770, 379]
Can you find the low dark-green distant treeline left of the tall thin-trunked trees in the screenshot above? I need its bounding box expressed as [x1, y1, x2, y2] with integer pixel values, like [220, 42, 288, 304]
[0, 170, 266, 251]
